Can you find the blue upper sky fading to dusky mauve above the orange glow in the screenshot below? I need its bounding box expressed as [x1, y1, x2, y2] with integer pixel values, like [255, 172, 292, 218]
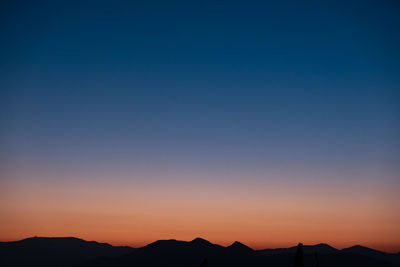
[0, 1, 400, 183]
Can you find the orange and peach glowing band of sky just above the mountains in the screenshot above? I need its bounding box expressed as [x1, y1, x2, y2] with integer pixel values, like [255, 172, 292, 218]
[0, 173, 400, 252]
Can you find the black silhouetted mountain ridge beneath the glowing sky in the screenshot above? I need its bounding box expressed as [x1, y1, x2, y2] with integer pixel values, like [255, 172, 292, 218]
[0, 237, 400, 267]
